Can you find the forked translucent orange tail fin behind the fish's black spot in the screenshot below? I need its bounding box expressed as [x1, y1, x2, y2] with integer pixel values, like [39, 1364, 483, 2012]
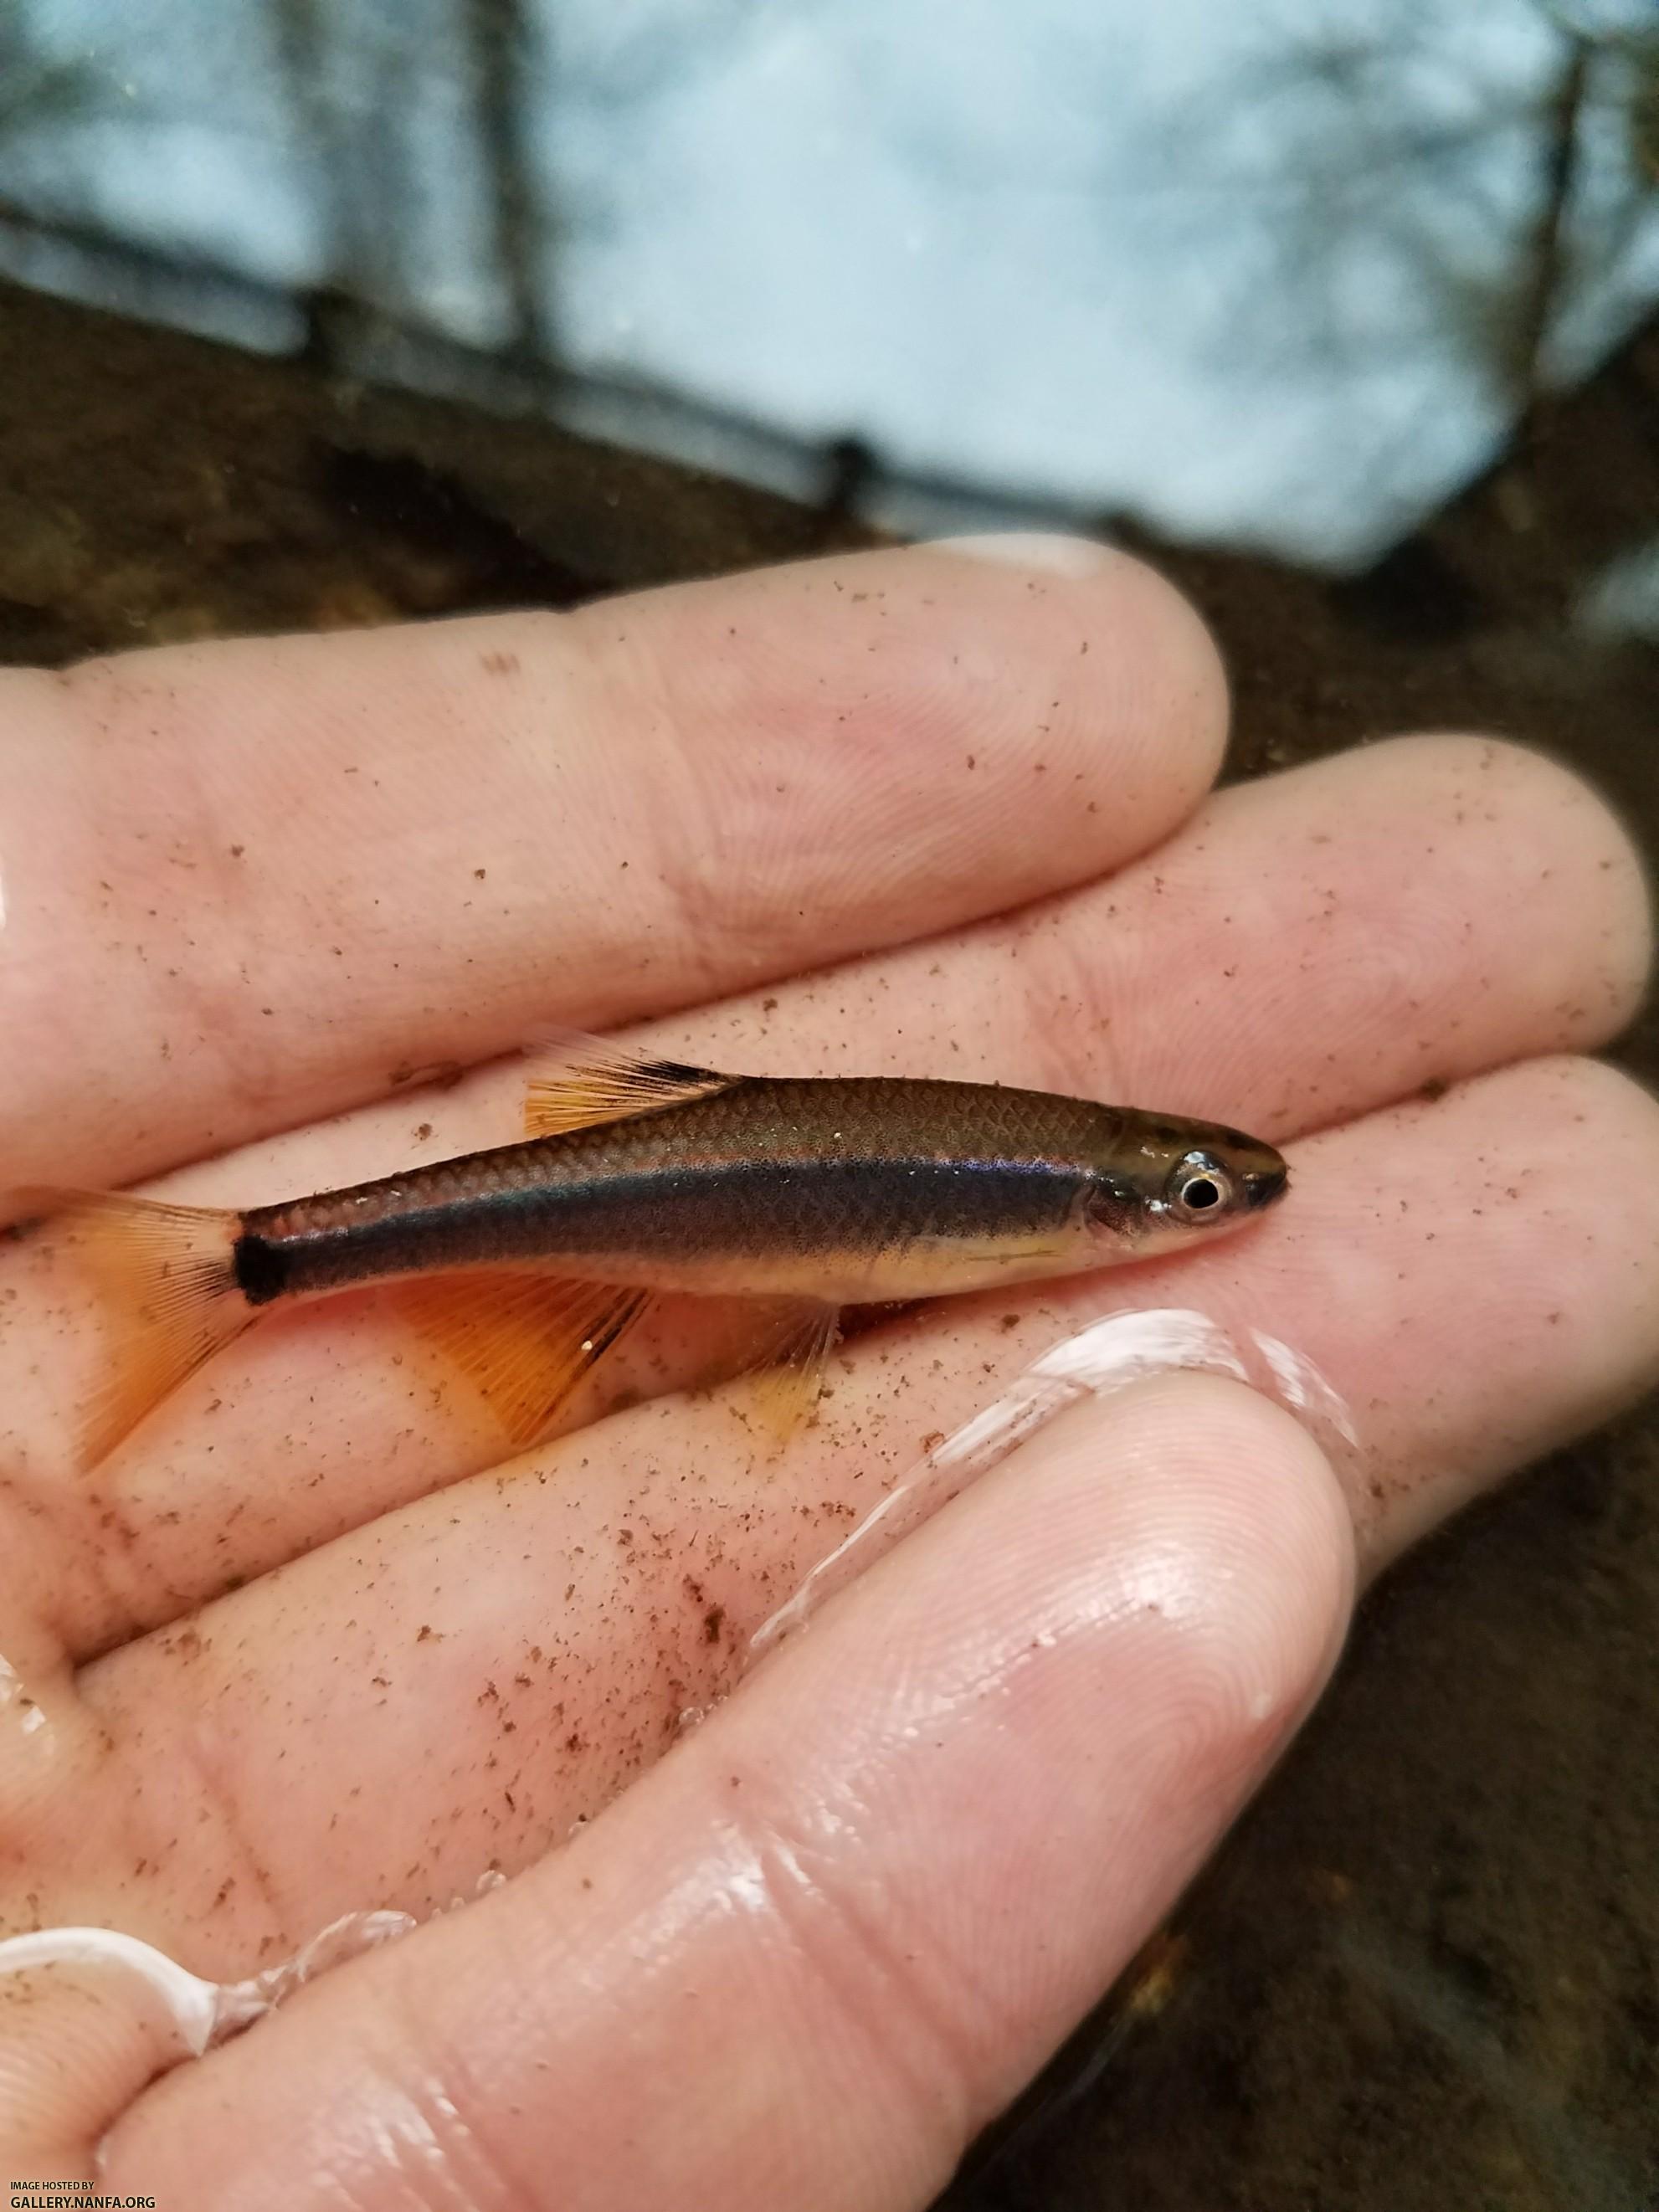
[11, 1188, 257, 1466]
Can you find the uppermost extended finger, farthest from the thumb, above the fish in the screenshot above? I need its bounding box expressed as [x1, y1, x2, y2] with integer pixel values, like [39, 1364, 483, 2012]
[0, 540, 1225, 1183]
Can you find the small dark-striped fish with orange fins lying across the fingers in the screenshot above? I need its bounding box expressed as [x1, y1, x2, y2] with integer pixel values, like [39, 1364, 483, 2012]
[13, 1033, 1287, 1465]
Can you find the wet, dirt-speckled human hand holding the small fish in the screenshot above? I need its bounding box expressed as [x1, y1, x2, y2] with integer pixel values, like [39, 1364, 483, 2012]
[0, 542, 1659, 2212]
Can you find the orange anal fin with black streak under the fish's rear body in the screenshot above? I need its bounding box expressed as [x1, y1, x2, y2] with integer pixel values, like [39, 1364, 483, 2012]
[398, 1270, 650, 1451]
